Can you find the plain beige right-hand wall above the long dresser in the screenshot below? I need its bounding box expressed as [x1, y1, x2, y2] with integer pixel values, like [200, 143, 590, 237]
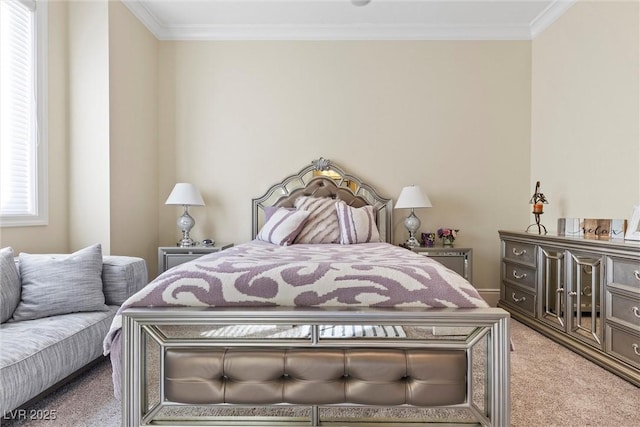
[531, 1, 640, 222]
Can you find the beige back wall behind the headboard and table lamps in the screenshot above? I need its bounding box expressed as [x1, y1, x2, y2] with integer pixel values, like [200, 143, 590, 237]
[160, 42, 531, 288]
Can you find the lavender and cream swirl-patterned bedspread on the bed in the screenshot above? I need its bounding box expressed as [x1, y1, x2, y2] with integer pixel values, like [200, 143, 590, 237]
[104, 240, 489, 398]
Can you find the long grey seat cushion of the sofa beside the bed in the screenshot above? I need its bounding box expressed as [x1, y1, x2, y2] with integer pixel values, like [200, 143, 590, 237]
[0, 306, 118, 414]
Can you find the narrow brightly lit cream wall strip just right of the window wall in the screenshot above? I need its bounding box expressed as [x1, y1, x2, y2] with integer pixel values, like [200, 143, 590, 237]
[68, 0, 111, 254]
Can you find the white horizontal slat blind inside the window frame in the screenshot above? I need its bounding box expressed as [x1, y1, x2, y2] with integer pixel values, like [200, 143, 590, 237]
[0, 0, 38, 216]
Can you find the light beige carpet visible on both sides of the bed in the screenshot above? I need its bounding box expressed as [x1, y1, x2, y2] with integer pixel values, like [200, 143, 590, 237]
[0, 321, 640, 427]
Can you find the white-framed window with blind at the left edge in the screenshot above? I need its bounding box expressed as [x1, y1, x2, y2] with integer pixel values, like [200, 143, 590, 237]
[0, 0, 48, 227]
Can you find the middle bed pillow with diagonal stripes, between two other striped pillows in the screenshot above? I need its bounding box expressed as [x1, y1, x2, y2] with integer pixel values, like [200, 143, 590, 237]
[293, 196, 340, 243]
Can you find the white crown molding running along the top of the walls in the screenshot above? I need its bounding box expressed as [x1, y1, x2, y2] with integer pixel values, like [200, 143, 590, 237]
[123, 0, 577, 40]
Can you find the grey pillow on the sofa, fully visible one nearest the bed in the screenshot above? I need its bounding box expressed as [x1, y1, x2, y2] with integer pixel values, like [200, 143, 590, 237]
[13, 244, 108, 320]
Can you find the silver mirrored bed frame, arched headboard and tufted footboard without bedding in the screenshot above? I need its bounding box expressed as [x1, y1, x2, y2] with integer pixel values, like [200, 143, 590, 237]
[122, 158, 510, 426]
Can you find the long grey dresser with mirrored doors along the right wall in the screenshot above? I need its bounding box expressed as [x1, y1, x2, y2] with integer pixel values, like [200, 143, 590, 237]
[498, 231, 640, 386]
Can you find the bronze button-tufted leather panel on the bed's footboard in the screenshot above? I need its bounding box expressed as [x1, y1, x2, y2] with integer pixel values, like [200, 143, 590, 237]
[164, 348, 467, 406]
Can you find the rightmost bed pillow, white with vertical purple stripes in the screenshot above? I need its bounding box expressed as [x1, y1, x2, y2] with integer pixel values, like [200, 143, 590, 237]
[336, 201, 380, 245]
